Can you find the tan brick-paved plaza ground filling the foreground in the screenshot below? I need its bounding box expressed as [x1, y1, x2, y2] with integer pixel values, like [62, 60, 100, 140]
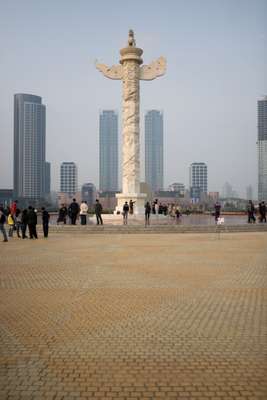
[0, 232, 267, 400]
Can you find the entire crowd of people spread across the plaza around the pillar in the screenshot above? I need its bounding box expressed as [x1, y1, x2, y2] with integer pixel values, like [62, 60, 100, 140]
[0, 199, 266, 242]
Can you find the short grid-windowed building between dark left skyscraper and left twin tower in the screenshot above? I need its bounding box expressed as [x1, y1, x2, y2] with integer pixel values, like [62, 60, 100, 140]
[60, 162, 78, 196]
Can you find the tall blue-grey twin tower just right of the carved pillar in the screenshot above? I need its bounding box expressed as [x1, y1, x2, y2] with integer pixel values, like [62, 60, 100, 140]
[145, 110, 163, 192]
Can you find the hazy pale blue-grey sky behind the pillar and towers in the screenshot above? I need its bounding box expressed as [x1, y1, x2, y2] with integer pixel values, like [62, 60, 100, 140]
[0, 0, 267, 195]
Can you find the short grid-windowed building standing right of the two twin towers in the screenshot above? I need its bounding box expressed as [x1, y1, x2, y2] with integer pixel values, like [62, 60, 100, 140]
[189, 162, 208, 199]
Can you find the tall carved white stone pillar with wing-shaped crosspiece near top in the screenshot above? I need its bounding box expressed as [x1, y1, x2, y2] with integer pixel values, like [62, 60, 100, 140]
[96, 30, 166, 214]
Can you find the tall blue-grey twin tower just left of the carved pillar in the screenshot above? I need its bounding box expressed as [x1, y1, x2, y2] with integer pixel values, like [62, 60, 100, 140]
[99, 110, 119, 192]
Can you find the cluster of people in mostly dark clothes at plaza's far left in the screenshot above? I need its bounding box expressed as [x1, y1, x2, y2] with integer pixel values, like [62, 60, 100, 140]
[0, 200, 50, 242]
